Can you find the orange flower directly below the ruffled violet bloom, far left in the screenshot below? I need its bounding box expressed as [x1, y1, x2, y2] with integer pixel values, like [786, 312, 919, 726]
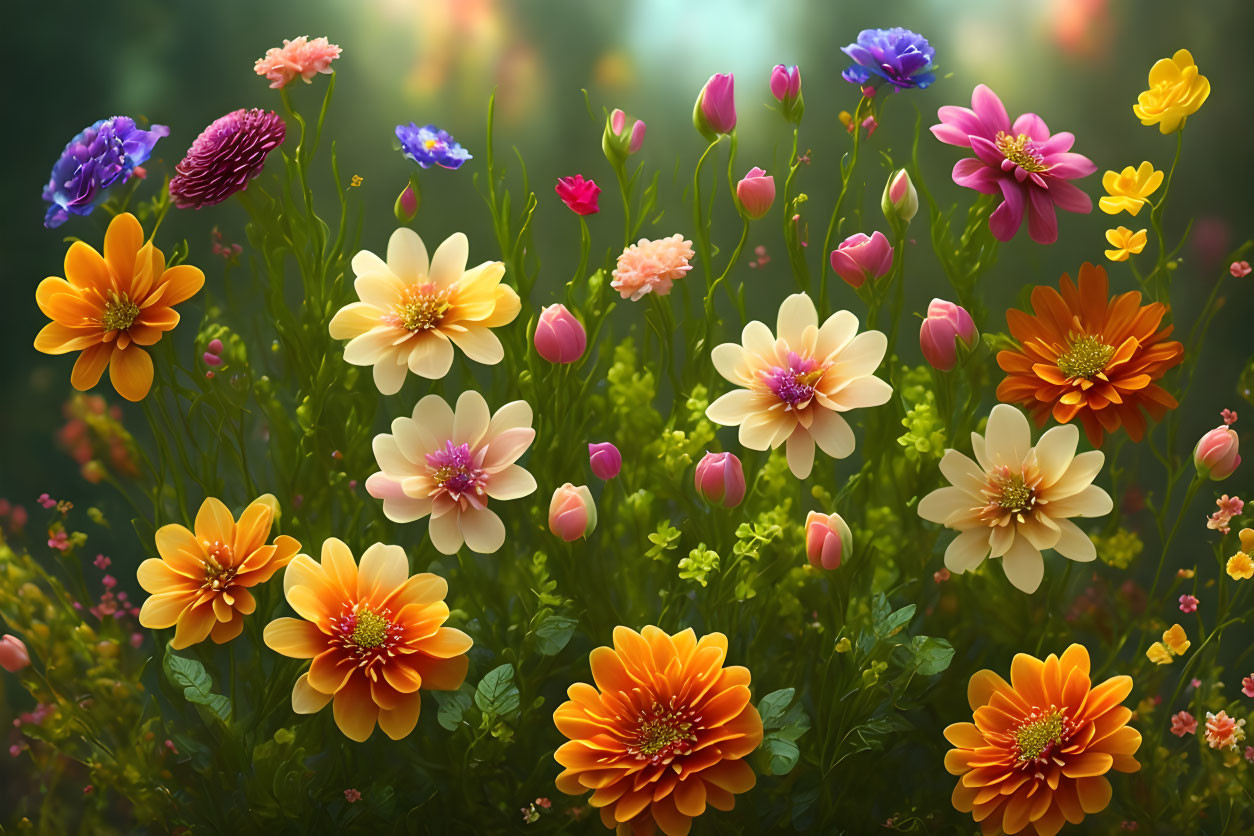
[35, 213, 204, 401]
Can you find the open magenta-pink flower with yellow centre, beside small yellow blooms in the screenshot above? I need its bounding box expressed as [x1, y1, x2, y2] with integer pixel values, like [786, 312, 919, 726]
[932, 84, 1097, 244]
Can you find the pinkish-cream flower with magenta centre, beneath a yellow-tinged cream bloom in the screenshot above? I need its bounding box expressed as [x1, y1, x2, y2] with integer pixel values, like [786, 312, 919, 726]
[366, 391, 535, 554]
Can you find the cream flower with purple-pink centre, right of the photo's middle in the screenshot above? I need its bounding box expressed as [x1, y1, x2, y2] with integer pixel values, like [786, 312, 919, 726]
[706, 293, 893, 479]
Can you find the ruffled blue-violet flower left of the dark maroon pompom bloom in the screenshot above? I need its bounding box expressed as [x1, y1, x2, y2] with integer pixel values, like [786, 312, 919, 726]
[44, 117, 169, 229]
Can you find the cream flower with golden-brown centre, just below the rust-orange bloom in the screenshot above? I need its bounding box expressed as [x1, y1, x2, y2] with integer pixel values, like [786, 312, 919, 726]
[919, 404, 1114, 593]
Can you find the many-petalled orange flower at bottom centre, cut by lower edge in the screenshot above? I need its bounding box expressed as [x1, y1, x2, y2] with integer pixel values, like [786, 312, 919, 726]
[553, 627, 762, 836]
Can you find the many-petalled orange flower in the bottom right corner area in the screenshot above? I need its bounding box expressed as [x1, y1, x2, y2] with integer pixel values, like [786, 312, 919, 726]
[944, 644, 1141, 836]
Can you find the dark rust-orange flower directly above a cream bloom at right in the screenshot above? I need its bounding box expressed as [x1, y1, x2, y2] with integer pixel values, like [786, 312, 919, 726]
[997, 263, 1184, 446]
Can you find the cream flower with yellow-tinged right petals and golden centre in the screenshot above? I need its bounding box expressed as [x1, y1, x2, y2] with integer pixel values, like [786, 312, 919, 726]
[330, 227, 522, 395]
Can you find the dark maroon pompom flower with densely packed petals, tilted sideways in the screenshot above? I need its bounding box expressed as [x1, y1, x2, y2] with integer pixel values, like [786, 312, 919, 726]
[169, 108, 287, 209]
